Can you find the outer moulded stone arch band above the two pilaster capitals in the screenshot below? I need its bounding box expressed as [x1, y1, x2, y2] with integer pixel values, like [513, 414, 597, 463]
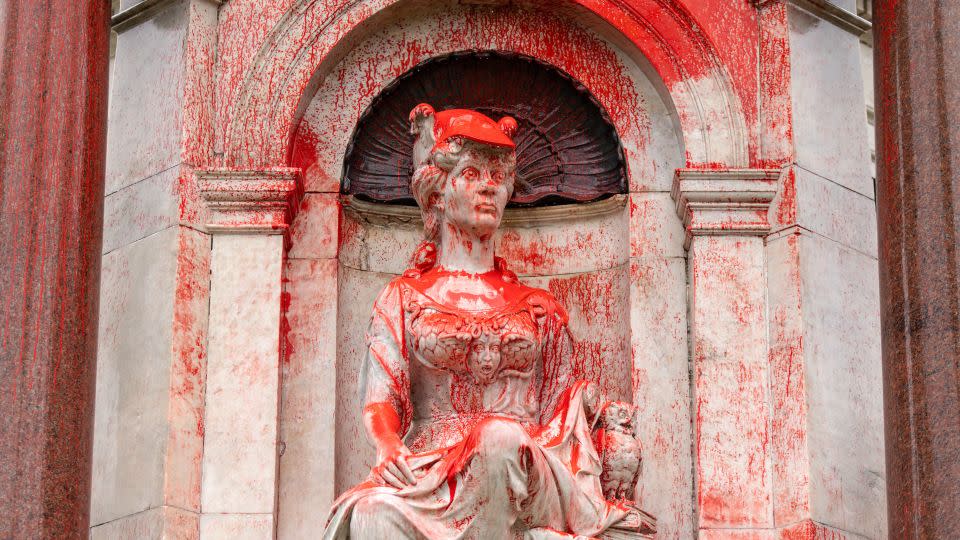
[220, 0, 756, 171]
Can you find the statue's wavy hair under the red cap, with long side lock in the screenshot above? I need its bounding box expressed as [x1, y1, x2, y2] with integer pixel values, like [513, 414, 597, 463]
[410, 138, 516, 271]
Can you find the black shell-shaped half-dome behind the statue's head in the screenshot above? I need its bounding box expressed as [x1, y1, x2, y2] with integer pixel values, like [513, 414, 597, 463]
[342, 51, 627, 207]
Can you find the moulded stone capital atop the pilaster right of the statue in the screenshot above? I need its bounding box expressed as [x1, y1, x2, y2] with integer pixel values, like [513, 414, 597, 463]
[670, 169, 780, 248]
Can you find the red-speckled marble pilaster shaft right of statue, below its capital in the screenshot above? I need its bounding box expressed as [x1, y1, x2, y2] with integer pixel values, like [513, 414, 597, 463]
[689, 236, 773, 528]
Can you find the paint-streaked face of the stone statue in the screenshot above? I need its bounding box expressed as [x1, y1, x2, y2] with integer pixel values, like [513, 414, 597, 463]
[443, 146, 514, 238]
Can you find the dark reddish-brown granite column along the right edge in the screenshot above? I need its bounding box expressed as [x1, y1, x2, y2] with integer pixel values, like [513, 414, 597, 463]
[874, 0, 960, 538]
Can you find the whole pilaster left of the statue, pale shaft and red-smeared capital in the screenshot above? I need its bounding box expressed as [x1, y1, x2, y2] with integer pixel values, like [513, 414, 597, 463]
[197, 169, 299, 538]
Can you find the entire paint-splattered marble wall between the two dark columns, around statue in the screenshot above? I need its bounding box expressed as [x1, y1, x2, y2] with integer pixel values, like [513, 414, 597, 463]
[91, 0, 886, 538]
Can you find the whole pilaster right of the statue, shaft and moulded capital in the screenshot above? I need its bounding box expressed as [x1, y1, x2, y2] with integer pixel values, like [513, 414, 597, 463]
[673, 170, 779, 538]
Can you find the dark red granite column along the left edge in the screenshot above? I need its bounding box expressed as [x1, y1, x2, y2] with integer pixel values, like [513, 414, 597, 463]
[0, 0, 110, 538]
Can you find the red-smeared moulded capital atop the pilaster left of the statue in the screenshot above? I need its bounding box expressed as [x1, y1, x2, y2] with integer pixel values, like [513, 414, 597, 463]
[196, 168, 303, 234]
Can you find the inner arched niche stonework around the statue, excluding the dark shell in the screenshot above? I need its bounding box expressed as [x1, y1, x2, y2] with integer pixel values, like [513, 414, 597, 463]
[278, 5, 693, 537]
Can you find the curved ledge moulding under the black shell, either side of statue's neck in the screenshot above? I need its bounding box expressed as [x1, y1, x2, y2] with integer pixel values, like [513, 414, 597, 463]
[342, 195, 627, 229]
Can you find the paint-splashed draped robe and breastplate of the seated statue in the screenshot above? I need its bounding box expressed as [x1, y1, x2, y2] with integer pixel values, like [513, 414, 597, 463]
[324, 267, 628, 539]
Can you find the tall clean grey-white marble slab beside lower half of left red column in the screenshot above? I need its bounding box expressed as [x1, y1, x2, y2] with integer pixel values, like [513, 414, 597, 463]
[90, 228, 177, 525]
